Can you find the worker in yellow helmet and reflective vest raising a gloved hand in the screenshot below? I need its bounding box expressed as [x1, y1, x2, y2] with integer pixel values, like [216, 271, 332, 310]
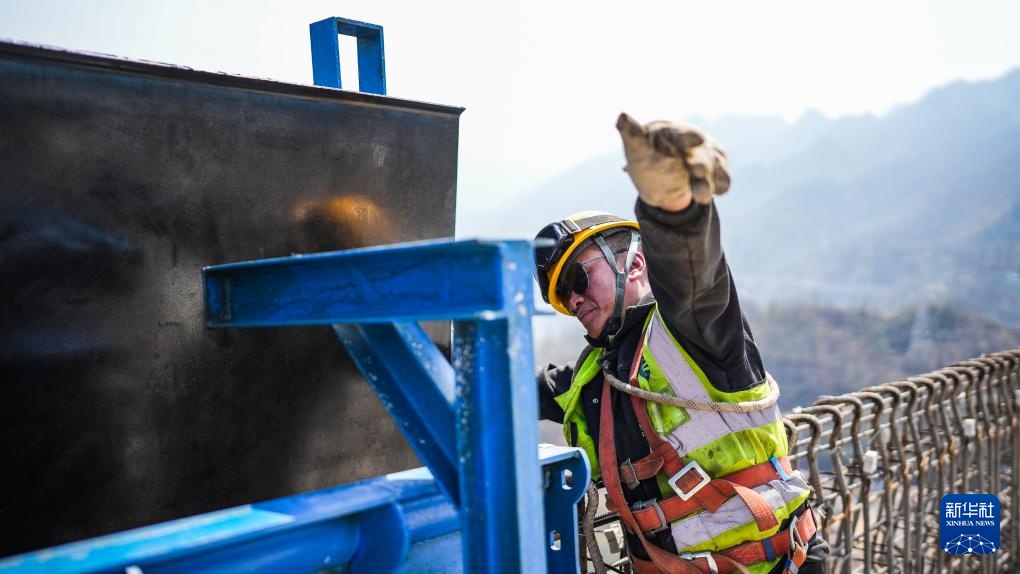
[536, 114, 828, 574]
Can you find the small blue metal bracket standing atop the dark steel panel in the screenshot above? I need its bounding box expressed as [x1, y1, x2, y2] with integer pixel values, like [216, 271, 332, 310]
[308, 16, 386, 96]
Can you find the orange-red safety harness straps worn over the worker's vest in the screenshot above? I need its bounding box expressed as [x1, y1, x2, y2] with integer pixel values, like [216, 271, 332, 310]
[599, 334, 816, 574]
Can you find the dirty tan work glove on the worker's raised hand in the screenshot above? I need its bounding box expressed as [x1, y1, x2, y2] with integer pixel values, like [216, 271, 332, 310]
[616, 113, 729, 207]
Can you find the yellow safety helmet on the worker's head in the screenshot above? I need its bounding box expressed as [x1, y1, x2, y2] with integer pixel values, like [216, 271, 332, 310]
[534, 211, 639, 315]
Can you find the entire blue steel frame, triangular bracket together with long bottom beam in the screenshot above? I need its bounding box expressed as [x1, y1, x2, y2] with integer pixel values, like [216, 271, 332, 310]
[0, 242, 591, 574]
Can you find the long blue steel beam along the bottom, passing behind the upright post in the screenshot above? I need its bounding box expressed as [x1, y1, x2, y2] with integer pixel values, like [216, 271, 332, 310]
[0, 447, 589, 574]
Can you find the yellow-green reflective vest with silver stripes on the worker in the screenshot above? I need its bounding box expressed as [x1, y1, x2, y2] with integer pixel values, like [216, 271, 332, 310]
[556, 306, 810, 573]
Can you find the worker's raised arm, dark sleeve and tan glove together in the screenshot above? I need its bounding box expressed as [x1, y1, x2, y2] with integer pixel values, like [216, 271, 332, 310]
[617, 114, 761, 381]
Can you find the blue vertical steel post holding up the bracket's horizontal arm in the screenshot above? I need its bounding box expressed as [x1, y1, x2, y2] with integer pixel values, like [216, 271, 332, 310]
[454, 242, 547, 574]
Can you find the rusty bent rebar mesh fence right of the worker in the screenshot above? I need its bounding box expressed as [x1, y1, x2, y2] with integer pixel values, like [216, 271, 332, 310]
[786, 349, 1020, 574]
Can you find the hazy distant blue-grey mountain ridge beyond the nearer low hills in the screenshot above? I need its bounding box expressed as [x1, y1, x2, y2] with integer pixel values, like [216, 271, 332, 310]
[461, 69, 1020, 326]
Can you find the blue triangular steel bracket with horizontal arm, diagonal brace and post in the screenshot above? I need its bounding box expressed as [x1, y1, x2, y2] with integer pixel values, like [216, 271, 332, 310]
[205, 242, 587, 572]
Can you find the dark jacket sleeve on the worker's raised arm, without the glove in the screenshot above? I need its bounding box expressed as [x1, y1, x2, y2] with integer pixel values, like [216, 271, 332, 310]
[634, 200, 765, 390]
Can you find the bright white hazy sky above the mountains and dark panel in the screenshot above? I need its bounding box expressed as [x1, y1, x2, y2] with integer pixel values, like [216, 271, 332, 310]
[0, 0, 1020, 184]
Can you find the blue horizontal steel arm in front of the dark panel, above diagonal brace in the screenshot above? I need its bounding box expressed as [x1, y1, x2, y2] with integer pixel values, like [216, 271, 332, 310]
[204, 242, 510, 328]
